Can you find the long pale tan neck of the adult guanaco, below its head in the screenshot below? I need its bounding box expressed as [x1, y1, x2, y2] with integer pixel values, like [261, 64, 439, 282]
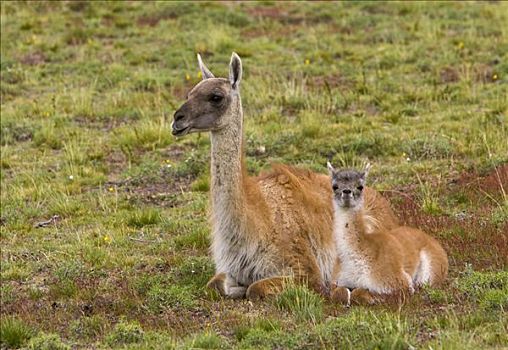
[211, 94, 245, 226]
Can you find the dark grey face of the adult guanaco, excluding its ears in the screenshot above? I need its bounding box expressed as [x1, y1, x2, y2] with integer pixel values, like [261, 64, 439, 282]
[172, 78, 232, 136]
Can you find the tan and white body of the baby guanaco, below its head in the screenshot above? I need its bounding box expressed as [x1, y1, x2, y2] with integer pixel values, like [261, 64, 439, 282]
[332, 208, 448, 304]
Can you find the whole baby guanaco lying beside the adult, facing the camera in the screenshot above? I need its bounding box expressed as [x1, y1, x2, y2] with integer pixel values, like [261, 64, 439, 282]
[327, 163, 448, 305]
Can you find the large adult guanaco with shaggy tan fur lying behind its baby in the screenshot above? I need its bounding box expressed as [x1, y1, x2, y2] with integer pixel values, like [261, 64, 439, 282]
[172, 54, 396, 299]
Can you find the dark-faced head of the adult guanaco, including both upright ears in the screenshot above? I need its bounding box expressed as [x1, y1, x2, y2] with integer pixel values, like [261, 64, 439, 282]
[172, 52, 242, 136]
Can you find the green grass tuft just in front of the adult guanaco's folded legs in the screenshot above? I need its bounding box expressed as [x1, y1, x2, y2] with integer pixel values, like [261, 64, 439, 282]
[275, 286, 323, 322]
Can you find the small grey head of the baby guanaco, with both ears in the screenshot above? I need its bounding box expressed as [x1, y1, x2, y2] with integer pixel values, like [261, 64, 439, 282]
[327, 162, 370, 209]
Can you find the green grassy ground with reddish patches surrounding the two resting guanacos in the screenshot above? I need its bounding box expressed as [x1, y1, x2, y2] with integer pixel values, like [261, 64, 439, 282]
[0, 2, 508, 349]
